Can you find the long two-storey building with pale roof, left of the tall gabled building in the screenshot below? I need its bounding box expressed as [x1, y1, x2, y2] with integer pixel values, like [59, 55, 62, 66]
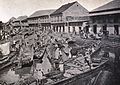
[28, 10, 55, 30]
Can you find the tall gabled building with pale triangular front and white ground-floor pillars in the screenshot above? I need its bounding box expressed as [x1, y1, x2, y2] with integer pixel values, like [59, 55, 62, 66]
[50, 1, 89, 33]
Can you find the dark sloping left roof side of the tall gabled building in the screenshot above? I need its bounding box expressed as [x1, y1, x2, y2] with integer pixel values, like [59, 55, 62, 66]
[51, 1, 77, 15]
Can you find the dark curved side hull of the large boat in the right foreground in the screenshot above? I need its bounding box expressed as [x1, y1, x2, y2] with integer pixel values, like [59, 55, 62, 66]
[45, 61, 107, 85]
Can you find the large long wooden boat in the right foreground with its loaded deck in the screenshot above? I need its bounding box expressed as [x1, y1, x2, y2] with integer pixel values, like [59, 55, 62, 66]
[44, 48, 108, 85]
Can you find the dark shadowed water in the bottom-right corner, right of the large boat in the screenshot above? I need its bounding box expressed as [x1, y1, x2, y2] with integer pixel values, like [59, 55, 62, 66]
[101, 48, 120, 85]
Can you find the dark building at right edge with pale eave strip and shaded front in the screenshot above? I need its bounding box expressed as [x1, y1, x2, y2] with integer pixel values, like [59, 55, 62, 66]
[89, 0, 120, 35]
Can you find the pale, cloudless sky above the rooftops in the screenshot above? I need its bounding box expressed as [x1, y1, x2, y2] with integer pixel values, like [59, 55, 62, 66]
[0, 0, 112, 22]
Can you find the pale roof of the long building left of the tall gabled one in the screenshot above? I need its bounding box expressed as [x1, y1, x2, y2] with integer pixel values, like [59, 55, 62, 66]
[29, 9, 55, 18]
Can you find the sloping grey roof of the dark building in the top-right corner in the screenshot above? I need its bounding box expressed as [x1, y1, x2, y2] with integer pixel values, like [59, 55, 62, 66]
[90, 0, 120, 13]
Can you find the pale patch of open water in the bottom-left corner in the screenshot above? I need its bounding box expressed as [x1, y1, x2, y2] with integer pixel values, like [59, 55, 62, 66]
[0, 67, 31, 83]
